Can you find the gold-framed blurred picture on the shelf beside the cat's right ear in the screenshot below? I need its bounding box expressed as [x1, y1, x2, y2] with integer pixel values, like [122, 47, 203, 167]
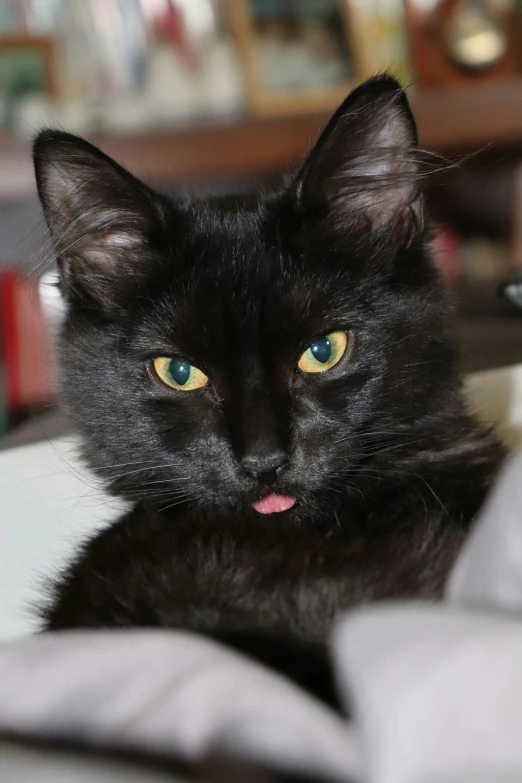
[228, 0, 367, 114]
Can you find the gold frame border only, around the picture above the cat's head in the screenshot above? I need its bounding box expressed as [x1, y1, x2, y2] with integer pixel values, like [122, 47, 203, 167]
[228, 0, 371, 116]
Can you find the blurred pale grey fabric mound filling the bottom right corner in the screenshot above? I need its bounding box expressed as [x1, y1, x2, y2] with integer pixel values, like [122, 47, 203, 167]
[335, 604, 522, 783]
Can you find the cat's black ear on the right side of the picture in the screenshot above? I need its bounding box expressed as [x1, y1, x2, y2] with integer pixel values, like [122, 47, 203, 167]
[294, 76, 423, 242]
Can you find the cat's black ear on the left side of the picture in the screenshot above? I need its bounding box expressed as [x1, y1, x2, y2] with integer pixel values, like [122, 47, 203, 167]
[33, 131, 162, 310]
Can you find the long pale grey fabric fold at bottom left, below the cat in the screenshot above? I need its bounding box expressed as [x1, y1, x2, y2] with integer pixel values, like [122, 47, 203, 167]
[0, 630, 360, 780]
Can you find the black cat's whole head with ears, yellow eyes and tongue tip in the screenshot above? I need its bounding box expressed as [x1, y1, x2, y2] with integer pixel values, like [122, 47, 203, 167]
[35, 77, 454, 518]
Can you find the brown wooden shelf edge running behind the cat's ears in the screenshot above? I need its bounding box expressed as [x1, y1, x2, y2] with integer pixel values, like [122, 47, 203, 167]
[0, 79, 522, 199]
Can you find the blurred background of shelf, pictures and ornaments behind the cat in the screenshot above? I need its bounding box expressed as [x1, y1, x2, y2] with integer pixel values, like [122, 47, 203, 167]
[0, 0, 522, 446]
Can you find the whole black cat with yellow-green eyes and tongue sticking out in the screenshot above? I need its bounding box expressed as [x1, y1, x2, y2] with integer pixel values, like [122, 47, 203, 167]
[34, 76, 502, 699]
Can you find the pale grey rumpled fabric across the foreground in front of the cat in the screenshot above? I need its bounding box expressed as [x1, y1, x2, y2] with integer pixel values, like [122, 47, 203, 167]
[0, 453, 522, 783]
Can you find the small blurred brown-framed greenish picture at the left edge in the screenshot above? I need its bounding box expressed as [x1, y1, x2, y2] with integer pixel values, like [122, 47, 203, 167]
[0, 35, 58, 127]
